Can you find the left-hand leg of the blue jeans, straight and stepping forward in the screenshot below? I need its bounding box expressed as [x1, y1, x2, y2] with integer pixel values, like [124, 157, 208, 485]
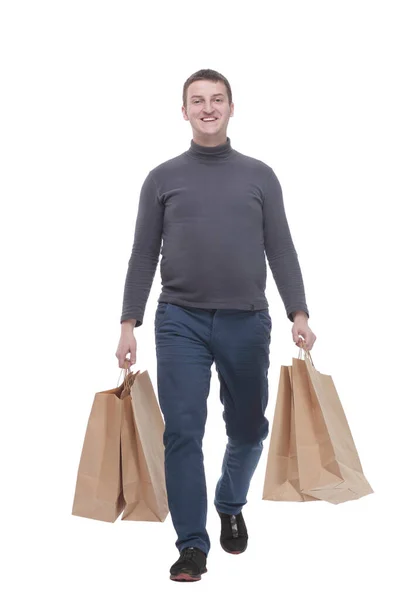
[155, 303, 213, 555]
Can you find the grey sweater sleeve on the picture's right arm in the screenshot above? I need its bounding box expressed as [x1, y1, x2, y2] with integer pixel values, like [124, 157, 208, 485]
[263, 167, 310, 322]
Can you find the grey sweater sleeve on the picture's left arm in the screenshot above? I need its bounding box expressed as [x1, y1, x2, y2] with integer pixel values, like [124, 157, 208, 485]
[120, 171, 164, 327]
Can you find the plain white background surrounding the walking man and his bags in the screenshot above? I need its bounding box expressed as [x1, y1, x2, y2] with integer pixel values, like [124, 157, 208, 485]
[0, 0, 400, 600]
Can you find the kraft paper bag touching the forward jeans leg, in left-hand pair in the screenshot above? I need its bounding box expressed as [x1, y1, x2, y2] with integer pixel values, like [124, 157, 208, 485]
[121, 371, 169, 521]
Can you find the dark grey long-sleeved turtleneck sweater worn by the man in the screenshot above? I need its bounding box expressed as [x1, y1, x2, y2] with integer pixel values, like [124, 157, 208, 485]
[120, 137, 309, 327]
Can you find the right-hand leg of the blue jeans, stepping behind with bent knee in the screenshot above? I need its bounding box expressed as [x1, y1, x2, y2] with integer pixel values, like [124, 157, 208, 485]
[211, 309, 272, 515]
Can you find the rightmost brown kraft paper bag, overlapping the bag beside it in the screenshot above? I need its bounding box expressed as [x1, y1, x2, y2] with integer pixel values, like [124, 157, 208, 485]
[291, 350, 373, 504]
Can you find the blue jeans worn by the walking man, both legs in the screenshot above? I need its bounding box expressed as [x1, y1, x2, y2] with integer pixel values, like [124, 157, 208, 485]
[154, 302, 272, 555]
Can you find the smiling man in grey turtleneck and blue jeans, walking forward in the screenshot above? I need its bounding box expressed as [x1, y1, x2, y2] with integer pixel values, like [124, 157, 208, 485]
[116, 69, 316, 581]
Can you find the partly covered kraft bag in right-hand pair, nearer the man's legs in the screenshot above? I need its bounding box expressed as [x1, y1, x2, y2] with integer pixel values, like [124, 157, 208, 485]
[262, 366, 316, 502]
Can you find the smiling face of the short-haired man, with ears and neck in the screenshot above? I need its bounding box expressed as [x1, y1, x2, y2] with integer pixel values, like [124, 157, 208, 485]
[182, 80, 234, 146]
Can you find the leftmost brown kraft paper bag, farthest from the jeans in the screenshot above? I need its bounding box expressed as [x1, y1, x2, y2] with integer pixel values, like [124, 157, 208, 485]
[72, 384, 125, 523]
